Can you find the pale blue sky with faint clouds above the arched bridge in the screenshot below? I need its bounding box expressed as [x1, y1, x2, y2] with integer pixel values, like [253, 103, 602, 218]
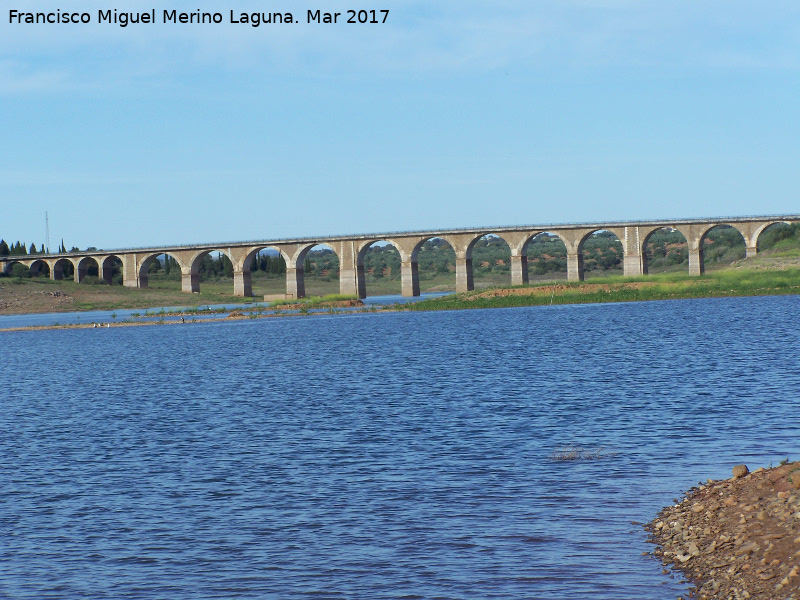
[0, 0, 800, 248]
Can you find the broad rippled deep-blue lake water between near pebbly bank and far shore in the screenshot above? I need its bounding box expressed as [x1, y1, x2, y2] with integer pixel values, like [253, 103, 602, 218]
[0, 296, 800, 600]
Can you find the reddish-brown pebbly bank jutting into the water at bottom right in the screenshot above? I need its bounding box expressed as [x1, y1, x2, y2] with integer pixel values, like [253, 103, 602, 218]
[645, 462, 800, 600]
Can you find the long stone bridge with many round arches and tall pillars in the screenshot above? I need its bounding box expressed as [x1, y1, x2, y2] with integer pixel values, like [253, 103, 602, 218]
[0, 215, 800, 298]
